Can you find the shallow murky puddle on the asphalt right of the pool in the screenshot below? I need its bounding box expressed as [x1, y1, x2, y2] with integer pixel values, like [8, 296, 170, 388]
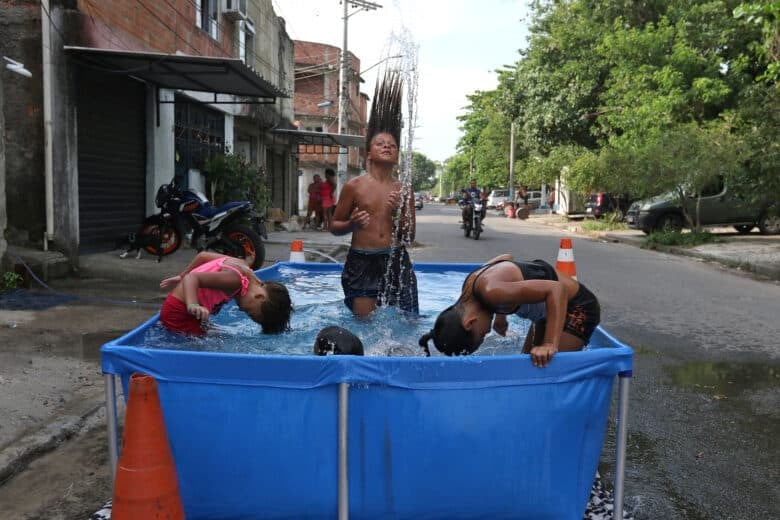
[669, 362, 780, 396]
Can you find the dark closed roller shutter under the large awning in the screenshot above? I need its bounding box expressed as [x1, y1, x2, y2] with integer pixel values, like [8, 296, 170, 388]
[77, 68, 146, 252]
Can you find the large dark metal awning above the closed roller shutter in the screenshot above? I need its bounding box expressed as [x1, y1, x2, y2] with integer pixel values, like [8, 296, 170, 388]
[64, 45, 290, 103]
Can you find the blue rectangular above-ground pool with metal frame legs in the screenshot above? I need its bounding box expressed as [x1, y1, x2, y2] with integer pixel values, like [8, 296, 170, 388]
[102, 263, 633, 520]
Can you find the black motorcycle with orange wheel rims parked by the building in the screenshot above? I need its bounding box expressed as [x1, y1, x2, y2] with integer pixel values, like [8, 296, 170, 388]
[141, 179, 268, 269]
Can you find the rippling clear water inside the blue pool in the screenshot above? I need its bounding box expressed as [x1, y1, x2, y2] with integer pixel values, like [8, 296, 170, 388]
[142, 267, 530, 356]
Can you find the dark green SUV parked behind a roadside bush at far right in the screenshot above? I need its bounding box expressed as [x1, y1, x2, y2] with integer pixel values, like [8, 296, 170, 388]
[626, 179, 780, 235]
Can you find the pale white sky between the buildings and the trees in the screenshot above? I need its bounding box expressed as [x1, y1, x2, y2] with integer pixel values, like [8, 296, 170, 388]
[273, 0, 528, 161]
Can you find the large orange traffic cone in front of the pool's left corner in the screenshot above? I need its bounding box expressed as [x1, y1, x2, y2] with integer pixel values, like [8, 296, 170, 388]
[111, 374, 184, 520]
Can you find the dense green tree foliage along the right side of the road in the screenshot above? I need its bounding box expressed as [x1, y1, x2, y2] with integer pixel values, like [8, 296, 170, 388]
[445, 0, 780, 215]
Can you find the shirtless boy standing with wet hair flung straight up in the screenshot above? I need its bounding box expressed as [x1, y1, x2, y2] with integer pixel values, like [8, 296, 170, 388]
[330, 73, 418, 317]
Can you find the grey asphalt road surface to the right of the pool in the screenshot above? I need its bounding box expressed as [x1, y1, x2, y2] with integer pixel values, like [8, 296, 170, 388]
[414, 206, 780, 520]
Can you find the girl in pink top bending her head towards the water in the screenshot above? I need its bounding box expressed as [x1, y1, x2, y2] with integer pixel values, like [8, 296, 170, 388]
[160, 252, 292, 336]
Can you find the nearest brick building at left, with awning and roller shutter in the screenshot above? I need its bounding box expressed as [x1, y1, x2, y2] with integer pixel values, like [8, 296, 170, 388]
[0, 0, 298, 267]
